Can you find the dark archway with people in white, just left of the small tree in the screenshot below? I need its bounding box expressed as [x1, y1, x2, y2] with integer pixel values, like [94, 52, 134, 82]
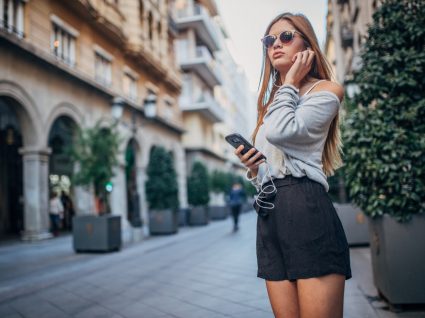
[48, 116, 77, 230]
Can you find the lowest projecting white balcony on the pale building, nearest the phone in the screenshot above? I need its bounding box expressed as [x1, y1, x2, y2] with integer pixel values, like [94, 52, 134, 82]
[180, 92, 224, 123]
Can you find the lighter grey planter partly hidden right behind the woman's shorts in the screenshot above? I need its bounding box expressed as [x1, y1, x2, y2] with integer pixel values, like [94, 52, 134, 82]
[334, 203, 369, 246]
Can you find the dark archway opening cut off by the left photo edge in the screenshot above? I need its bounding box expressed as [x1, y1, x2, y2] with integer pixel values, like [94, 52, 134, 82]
[0, 97, 24, 238]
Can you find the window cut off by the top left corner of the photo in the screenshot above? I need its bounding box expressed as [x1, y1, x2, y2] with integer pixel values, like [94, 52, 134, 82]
[0, 0, 24, 38]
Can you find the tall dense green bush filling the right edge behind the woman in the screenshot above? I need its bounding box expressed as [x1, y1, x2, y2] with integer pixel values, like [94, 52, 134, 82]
[343, 0, 425, 221]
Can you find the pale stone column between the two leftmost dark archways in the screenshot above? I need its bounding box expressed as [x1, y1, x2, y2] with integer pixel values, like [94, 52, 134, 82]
[19, 148, 52, 241]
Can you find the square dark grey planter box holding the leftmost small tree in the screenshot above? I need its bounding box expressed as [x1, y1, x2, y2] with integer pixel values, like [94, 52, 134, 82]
[72, 215, 121, 252]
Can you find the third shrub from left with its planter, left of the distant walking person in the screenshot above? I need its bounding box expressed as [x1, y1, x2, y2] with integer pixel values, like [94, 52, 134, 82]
[187, 162, 210, 225]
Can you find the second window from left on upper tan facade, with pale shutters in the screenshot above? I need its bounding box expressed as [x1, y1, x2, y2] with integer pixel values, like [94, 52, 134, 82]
[50, 15, 79, 66]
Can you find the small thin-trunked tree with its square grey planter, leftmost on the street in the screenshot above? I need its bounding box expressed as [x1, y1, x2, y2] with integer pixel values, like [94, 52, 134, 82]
[67, 121, 121, 251]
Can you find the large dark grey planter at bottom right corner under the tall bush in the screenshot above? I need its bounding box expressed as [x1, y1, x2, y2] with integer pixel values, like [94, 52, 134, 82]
[369, 215, 425, 305]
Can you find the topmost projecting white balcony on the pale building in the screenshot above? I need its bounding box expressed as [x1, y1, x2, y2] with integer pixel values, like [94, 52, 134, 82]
[176, 4, 220, 51]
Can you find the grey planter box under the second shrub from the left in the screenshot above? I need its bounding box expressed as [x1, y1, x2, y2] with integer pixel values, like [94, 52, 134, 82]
[149, 209, 179, 235]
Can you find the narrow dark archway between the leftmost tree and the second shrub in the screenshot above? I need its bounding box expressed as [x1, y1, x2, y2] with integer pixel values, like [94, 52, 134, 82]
[125, 138, 142, 227]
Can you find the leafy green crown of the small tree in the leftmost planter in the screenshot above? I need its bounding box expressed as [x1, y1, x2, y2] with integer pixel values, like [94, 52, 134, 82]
[66, 121, 121, 198]
